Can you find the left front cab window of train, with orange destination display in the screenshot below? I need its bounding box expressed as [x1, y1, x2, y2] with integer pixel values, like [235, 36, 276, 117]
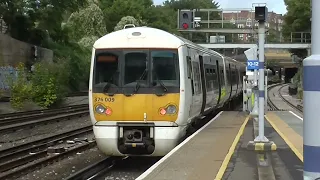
[94, 52, 119, 86]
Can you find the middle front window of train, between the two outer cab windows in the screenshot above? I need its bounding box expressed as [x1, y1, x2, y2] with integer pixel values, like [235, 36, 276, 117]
[124, 52, 148, 85]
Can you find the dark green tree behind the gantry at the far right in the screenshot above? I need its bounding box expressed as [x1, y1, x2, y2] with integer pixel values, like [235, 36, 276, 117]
[282, 0, 311, 58]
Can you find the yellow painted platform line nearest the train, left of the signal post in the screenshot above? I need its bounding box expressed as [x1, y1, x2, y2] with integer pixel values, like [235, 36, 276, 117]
[215, 116, 250, 180]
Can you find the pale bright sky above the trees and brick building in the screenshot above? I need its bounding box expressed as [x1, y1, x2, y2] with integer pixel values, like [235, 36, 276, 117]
[153, 0, 287, 14]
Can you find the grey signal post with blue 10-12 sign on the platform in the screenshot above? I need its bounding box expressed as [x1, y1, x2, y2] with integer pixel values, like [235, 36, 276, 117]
[247, 5, 277, 179]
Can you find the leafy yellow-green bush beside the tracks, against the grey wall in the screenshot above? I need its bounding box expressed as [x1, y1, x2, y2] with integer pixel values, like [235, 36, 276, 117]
[9, 60, 69, 109]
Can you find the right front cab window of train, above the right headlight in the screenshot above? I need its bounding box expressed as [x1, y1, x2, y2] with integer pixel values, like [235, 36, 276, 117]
[151, 50, 179, 87]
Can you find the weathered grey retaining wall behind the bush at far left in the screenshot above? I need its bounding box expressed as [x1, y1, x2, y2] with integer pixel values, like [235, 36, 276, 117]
[0, 33, 53, 90]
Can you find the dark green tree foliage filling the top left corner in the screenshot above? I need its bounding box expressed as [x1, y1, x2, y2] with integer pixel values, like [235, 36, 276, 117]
[0, 0, 87, 42]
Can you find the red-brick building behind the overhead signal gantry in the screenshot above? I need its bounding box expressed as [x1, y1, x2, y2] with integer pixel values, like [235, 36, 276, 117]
[223, 11, 283, 41]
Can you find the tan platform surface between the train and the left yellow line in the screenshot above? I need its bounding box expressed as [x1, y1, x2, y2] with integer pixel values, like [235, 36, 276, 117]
[140, 111, 247, 180]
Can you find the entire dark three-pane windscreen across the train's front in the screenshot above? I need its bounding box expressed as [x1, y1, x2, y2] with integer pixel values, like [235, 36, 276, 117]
[93, 49, 180, 92]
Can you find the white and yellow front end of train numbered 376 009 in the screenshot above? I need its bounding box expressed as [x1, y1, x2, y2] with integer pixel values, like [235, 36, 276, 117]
[89, 27, 188, 156]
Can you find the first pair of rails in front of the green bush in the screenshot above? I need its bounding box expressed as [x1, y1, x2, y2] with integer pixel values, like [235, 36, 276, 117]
[0, 105, 89, 133]
